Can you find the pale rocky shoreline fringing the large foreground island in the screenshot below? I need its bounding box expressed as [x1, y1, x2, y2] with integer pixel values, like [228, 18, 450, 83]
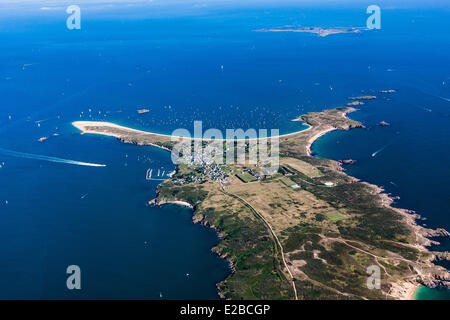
[75, 108, 450, 299]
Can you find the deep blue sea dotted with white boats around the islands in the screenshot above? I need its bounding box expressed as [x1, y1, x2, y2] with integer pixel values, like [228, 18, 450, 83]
[0, 1, 450, 299]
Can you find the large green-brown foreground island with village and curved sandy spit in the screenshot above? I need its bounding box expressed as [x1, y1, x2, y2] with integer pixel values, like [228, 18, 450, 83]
[73, 107, 450, 300]
